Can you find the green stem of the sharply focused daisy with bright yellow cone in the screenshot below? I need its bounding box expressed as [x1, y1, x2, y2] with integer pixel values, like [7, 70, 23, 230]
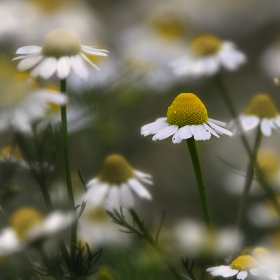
[186, 137, 212, 230]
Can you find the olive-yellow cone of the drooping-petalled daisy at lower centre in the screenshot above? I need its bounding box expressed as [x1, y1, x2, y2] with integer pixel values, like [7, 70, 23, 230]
[99, 154, 134, 184]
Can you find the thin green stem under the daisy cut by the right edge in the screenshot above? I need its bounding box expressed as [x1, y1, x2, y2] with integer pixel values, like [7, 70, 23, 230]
[236, 126, 262, 230]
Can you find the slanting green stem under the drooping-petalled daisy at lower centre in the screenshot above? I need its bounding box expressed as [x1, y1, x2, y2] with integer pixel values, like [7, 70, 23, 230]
[129, 208, 182, 280]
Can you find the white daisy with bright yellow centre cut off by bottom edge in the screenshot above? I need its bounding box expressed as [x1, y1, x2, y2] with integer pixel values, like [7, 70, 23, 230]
[206, 255, 279, 280]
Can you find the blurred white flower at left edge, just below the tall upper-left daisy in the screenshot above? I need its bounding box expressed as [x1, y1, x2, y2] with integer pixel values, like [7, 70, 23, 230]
[0, 68, 67, 132]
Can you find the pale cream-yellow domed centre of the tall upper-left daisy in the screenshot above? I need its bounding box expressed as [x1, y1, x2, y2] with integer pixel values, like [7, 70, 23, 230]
[42, 28, 81, 58]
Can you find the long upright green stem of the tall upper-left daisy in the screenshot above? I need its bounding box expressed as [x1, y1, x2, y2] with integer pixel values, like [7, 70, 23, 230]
[60, 79, 77, 259]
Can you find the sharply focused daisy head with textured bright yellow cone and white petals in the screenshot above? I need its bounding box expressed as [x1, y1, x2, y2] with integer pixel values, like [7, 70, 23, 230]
[141, 93, 232, 144]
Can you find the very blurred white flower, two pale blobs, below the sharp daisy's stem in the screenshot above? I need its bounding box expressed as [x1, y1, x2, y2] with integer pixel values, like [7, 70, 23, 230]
[174, 220, 242, 258]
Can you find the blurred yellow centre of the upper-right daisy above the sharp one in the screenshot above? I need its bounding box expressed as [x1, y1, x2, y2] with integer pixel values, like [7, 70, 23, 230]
[191, 33, 222, 56]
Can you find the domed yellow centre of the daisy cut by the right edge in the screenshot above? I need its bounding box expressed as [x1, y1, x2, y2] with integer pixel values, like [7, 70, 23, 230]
[245, 93, 278, 119]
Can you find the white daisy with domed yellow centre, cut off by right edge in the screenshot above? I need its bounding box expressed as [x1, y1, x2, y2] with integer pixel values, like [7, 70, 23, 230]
[239, 93, 280, 136]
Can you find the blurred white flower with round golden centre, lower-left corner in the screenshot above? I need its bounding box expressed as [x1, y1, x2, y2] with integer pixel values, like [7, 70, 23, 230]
[0, 207, 75, 256]
